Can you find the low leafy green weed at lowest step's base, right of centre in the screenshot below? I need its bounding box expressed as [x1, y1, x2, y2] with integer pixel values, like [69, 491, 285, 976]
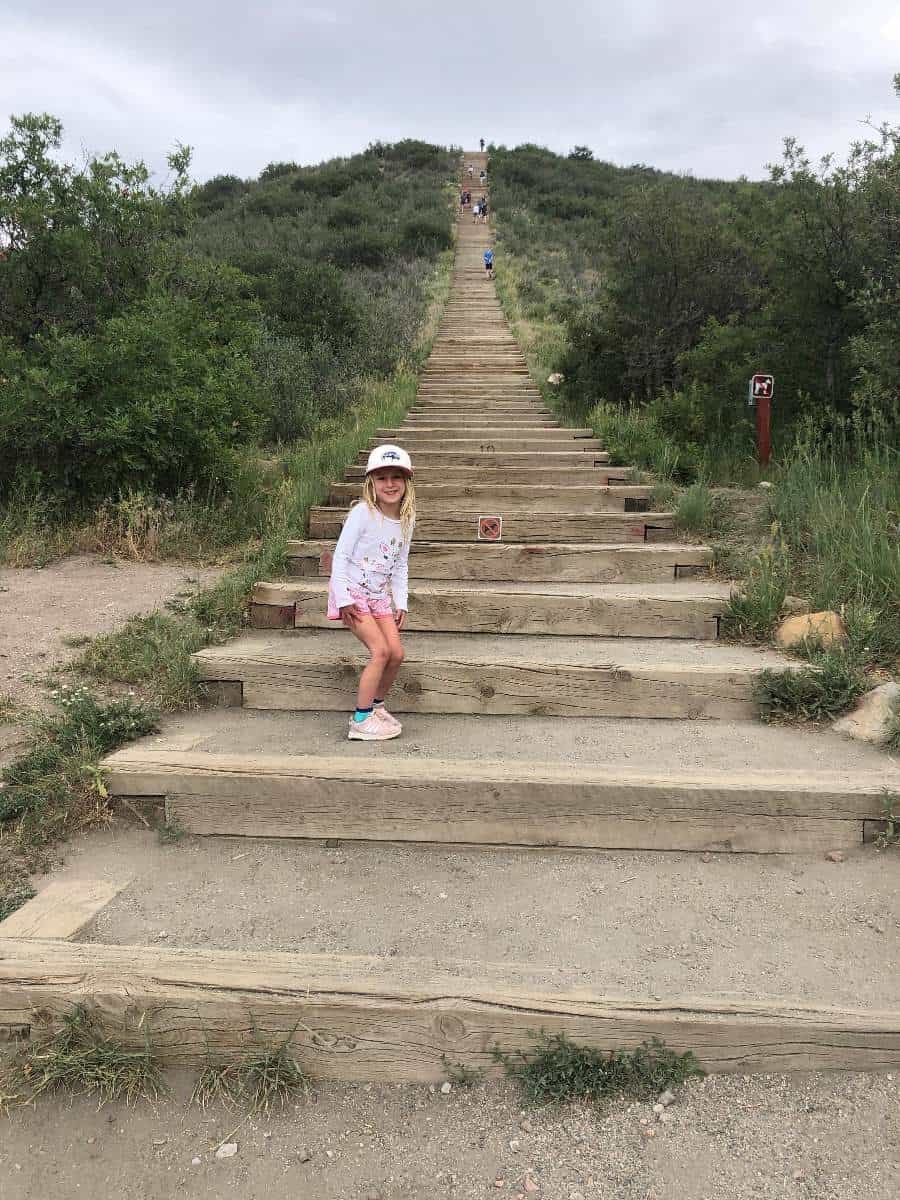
[493, 1030, 704, 1104]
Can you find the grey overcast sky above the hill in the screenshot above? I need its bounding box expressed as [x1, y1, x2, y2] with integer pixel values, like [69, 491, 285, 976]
[0, 0, 900, 180]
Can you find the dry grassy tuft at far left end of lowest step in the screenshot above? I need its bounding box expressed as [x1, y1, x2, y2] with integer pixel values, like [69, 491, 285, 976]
[4, 1006, 167, 1104]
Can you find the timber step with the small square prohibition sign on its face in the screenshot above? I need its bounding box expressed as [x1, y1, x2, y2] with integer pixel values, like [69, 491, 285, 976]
[310, 502, 674, 542]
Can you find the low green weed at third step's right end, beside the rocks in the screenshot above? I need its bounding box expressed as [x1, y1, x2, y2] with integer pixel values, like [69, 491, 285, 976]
[757, 647, 866, 722]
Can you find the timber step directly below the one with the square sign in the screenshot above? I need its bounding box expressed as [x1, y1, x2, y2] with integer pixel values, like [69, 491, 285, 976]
[287, 538, 713, 583]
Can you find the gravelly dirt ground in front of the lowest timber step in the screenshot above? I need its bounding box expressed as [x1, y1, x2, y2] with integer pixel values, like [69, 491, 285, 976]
[0, 1074, 900, 1200]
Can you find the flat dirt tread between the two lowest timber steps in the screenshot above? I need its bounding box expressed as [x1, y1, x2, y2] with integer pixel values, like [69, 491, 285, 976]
[45, 821, 900, 1009]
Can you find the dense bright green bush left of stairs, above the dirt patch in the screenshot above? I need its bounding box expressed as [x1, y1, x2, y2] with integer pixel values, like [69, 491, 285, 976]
[0, 267, 260, 500]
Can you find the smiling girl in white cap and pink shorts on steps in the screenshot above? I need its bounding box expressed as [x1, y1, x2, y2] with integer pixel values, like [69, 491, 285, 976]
[328, 445, 415, 742]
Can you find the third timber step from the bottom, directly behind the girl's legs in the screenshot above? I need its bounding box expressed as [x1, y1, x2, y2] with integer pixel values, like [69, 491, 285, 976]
[193, 629, 800, 720]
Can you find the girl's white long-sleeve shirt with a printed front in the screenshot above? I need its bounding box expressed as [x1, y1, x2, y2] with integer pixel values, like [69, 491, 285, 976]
[329, 500, 413, 611]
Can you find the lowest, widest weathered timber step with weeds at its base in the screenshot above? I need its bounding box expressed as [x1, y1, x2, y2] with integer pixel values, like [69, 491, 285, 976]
[0, 940, 900, 1082]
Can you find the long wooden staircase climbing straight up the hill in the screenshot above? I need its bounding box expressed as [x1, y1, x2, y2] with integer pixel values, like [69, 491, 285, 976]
[81, 155, 900, 1079]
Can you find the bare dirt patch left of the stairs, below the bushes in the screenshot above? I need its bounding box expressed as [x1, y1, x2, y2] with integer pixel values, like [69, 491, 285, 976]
[0, 554, 222, 763]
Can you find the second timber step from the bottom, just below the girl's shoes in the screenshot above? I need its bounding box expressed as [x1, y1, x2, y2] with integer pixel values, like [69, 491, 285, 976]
[103, 746, 900, 853]
